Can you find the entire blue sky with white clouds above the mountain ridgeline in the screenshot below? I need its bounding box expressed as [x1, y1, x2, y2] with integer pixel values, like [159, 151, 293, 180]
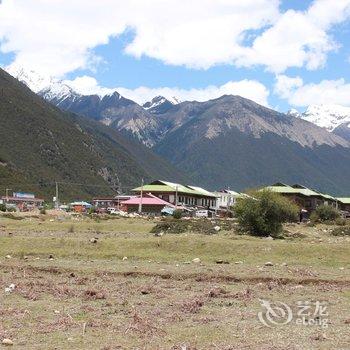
[0, 0, 350, 112]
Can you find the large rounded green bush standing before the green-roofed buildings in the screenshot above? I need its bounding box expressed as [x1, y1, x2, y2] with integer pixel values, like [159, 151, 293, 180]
[234, 190, 299, 237]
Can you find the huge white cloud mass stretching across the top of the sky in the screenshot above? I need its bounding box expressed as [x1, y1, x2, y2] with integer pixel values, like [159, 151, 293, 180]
[0, 0, 350, 77]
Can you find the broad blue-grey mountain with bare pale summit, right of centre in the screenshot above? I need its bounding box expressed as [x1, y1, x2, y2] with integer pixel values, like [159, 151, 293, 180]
[154, 96, 350, 195]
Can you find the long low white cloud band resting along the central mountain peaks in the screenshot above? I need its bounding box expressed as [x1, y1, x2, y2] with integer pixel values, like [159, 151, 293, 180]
[65, 76, 269, 106]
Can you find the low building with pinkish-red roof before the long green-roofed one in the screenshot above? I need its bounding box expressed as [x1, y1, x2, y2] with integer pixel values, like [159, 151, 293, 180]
[121, 193, 175, 215]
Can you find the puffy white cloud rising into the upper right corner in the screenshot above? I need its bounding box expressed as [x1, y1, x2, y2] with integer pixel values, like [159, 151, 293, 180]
[237, 0, 350, 73]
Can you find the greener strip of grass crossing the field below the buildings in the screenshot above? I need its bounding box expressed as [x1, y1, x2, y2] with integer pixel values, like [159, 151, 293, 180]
[0, 233, 350, 267]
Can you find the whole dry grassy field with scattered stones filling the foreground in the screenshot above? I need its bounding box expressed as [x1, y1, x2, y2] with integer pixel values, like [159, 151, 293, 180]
[0, 215, 350, 350]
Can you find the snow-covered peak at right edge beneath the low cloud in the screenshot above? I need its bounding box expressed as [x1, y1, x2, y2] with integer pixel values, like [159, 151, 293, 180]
[288, 104, 350, 132]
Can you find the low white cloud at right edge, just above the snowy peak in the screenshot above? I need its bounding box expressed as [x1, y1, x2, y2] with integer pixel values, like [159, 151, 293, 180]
[274, 75, 350, 107]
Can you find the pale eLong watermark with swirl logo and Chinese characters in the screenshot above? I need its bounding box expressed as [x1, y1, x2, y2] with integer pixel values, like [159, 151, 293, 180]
[258, 299, 329, 328]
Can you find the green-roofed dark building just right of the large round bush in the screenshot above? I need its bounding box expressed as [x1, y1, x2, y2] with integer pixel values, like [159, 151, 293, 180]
[265, 182, 337, 214]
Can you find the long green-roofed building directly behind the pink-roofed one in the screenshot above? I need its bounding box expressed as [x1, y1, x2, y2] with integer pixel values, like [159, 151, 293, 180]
[132, 180, 216, 208]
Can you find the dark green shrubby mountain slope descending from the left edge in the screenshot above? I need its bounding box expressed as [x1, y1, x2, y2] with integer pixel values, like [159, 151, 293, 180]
[0, 70, 183, 199]
